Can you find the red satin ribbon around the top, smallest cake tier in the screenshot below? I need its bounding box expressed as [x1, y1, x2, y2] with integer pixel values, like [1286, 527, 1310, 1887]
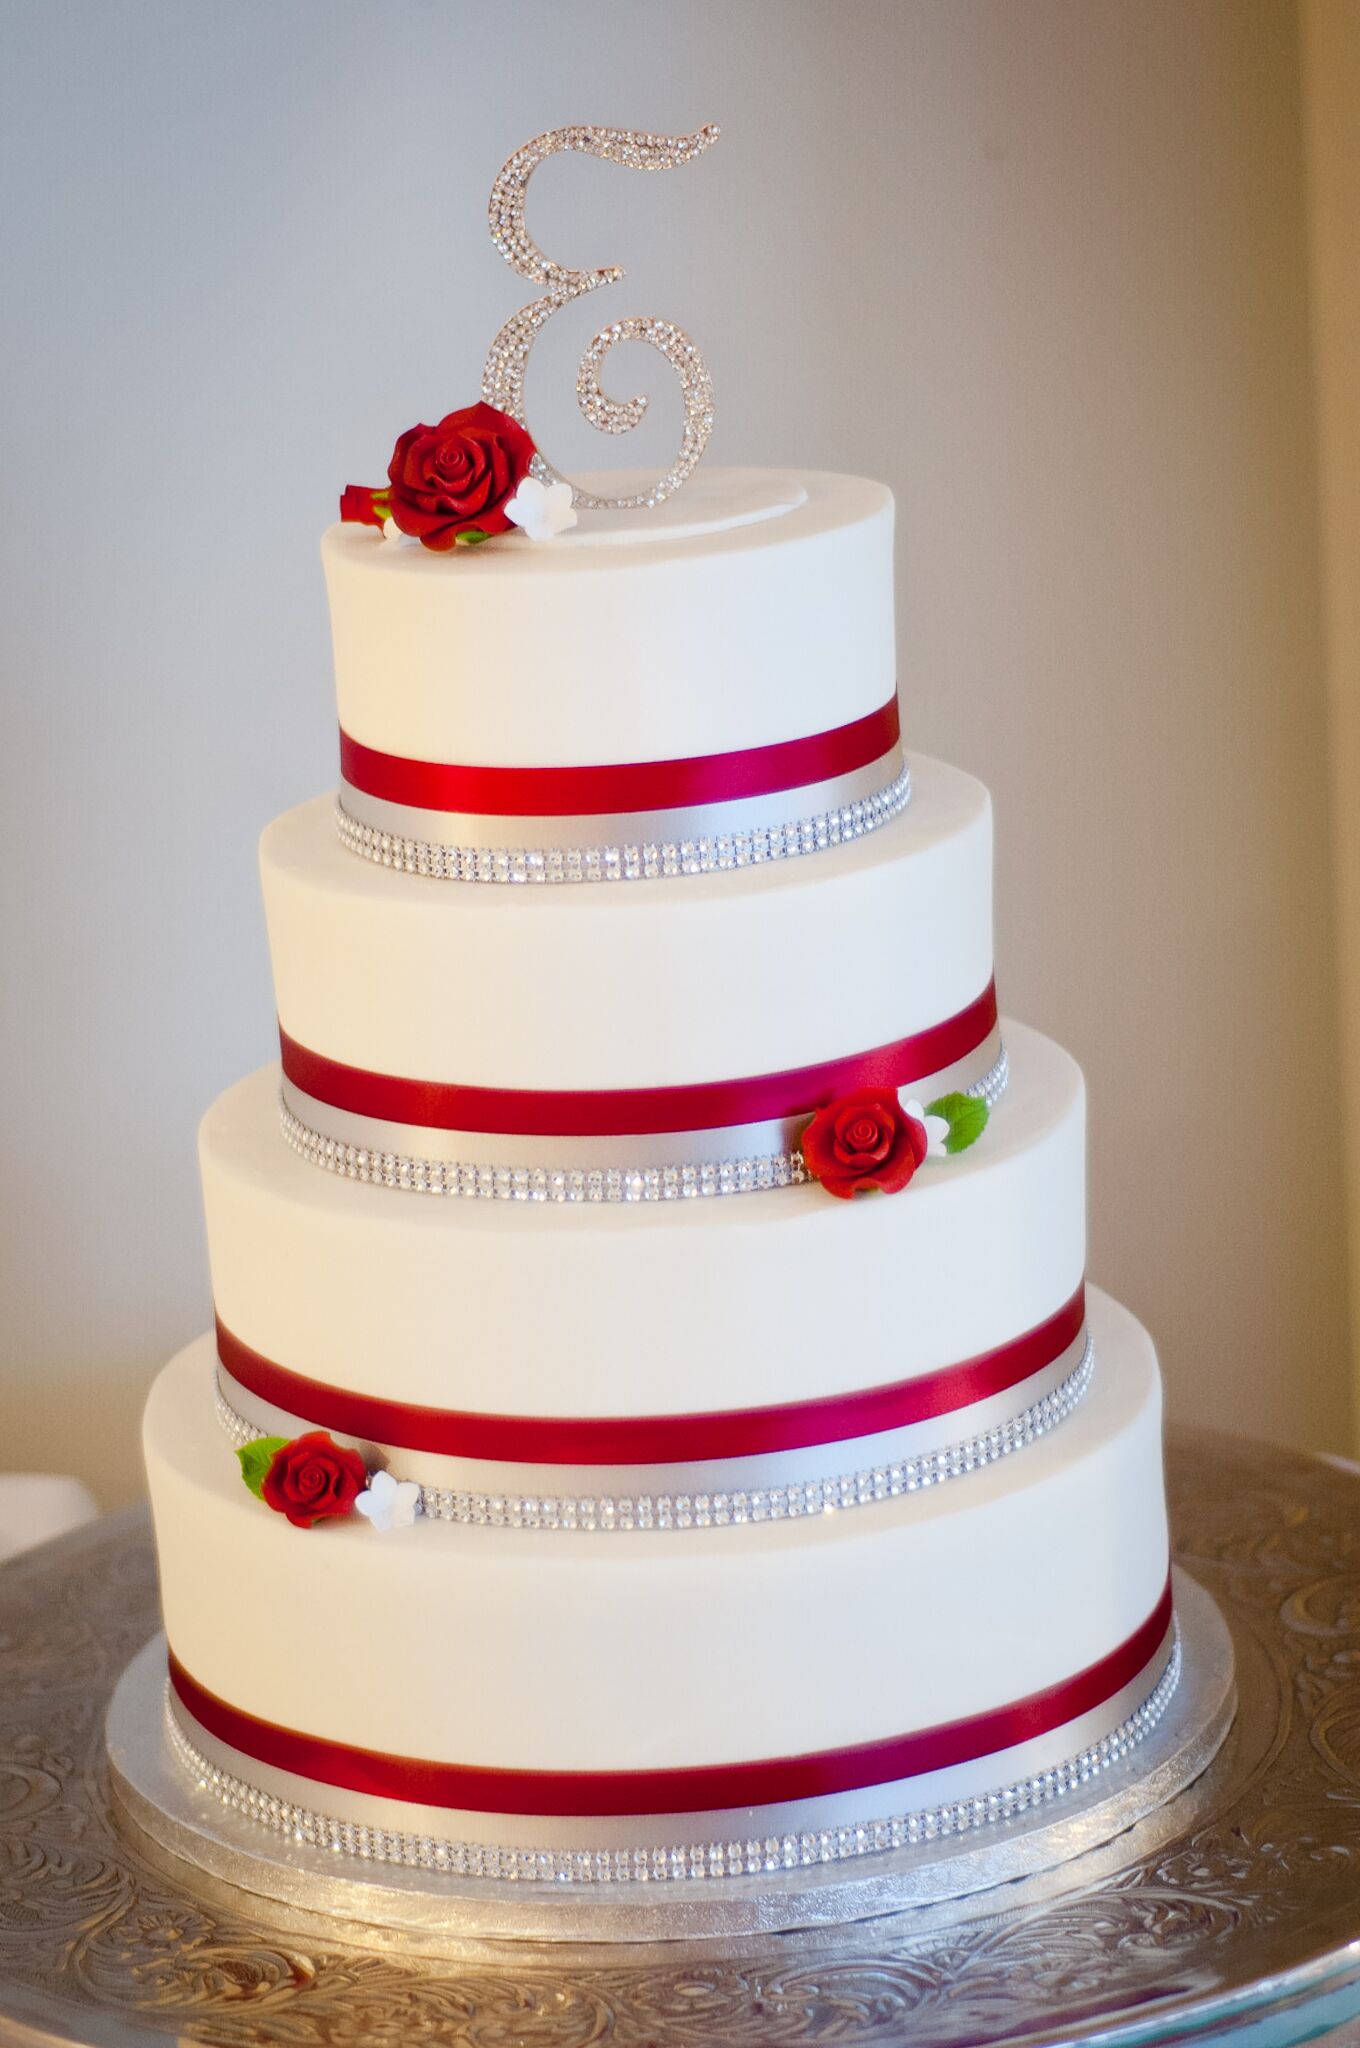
[340, 694, 901, 817]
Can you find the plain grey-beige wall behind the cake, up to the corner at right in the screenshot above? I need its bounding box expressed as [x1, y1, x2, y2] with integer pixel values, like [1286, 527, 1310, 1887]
[0, 0, 1350, 1503]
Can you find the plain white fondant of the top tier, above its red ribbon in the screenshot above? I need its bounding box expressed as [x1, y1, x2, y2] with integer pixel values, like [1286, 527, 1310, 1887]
[322, 469, 897, 766]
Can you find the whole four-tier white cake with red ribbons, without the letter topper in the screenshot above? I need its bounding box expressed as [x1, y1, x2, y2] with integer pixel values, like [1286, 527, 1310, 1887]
[145, 471, 1178, 1882]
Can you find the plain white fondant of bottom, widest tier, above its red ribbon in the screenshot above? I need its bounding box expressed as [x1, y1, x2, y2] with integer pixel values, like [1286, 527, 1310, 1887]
[145, 1294, 1167, 1769]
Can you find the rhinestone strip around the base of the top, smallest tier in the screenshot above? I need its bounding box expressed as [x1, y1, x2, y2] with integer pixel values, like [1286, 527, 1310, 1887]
[336, 768, 911, 883]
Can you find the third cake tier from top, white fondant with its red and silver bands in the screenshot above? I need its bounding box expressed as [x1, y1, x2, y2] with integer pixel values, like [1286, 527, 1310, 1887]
[201, 1024, 1090, 1518]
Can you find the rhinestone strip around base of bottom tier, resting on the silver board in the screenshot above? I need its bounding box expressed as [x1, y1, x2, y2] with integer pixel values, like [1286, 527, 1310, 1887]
[166, 1630, 1182, 1884]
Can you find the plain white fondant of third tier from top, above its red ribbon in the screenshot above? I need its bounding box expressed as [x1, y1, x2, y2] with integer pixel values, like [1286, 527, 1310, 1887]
[199, 1022, 1086, 1415]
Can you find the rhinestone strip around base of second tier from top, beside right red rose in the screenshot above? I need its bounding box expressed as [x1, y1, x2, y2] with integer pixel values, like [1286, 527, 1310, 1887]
[279, 1047, 1010, 1202]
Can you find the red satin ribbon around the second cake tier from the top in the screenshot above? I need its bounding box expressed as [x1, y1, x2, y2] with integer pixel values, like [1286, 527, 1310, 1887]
[279, 983, 997, 1139]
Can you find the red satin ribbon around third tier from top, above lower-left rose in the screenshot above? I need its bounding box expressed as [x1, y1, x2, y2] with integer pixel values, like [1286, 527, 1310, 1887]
[217, 1288, 1086, 1464]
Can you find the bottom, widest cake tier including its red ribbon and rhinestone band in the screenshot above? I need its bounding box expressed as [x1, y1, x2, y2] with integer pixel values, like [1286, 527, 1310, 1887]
[145, 1292, 1180, 1882]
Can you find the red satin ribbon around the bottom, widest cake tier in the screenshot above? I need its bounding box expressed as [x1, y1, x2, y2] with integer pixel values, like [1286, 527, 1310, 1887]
[170, 1572, 1172, 1819]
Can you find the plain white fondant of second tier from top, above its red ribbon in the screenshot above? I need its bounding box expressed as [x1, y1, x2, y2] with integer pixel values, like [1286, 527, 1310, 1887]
[260, 756, 991, 1090]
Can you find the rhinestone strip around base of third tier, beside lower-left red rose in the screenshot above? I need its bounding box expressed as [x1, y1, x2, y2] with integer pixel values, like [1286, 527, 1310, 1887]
[217, 1333, 1096, 1532]
